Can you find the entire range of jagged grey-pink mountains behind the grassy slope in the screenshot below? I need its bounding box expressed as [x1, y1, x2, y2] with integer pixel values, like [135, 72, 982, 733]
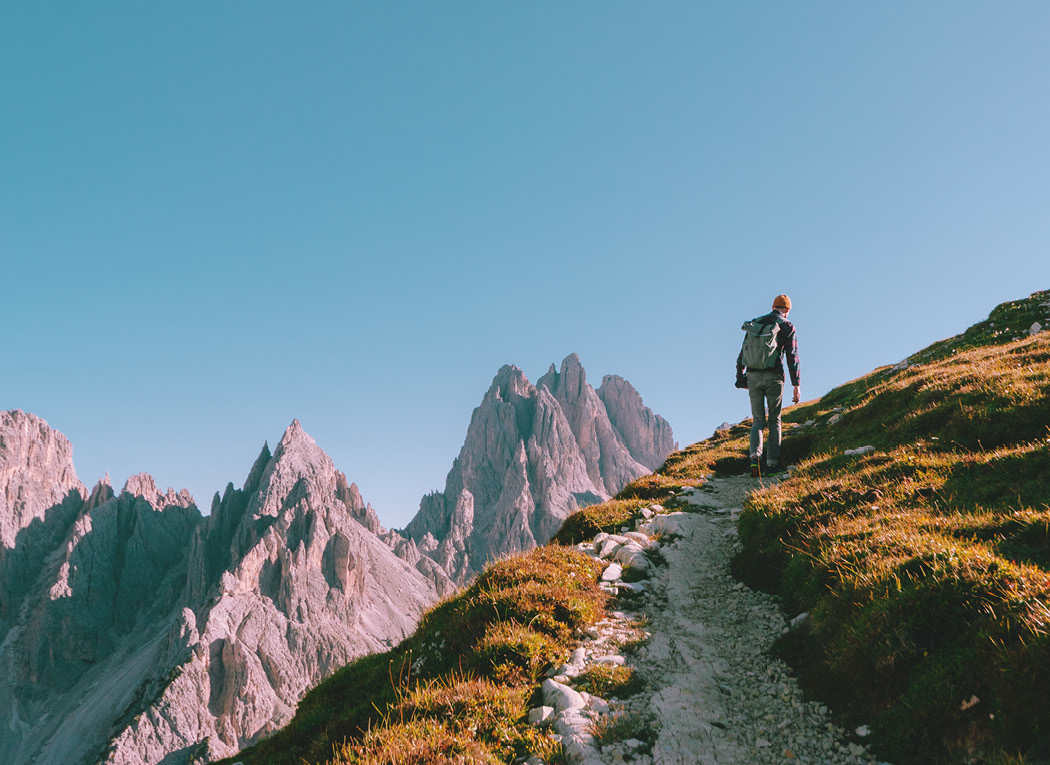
[0, 355, 676, 765]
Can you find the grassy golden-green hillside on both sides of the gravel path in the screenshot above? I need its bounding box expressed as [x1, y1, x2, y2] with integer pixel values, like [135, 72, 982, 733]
[217, 292, 1050, 764]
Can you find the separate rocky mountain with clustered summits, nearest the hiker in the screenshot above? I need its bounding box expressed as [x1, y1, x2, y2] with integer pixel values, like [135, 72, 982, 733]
[404, 354, 674, 583]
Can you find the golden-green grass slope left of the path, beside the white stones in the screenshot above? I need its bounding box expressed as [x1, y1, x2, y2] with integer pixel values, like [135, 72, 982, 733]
[216, 546, 608, 765]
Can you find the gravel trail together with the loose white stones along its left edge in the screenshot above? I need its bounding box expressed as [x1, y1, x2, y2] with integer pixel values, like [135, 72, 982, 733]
[528, 476, 894, 765]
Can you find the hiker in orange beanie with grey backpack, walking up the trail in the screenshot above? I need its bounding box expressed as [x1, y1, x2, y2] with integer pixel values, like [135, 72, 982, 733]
[736, 295, 802, 479]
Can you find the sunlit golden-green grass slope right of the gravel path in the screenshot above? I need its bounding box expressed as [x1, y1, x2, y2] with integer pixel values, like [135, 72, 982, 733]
[730, 293, 1050, 763]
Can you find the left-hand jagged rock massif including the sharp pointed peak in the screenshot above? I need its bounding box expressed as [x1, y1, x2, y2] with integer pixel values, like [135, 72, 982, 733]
[0, 412, 440, 765]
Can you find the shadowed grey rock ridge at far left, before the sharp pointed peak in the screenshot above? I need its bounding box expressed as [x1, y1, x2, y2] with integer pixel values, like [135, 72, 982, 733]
[0, 451, 202, 763]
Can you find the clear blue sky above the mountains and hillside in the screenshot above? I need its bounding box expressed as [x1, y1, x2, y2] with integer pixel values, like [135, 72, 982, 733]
[0, 0, 1050, 526]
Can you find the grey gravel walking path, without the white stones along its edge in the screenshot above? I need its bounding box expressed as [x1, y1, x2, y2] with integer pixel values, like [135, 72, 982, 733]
[637, 476, 875, 765]
